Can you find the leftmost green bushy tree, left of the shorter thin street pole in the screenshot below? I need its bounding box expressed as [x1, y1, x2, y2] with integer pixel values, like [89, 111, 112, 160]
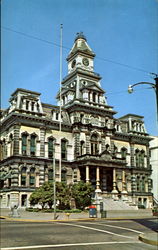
[29, 182, 53, 209]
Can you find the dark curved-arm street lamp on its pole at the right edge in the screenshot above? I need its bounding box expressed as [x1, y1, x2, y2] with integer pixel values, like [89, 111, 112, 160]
[128, 75, 158, 122]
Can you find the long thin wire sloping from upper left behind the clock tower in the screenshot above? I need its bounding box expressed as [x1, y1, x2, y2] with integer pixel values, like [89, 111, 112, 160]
[1, 26, 156, 74]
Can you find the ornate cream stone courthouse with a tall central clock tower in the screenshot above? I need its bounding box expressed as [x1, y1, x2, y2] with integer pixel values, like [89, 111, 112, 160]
[0, 33, 152, 208]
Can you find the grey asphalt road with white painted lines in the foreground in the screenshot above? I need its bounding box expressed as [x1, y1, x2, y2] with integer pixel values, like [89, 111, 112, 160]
[1, 219, 157, 250]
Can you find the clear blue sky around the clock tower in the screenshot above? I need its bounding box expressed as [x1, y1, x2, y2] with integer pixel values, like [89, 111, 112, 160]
[1, 0, 158, 135]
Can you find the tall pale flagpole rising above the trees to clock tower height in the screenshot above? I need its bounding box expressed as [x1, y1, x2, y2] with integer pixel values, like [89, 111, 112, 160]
[59, 24, 63, 182]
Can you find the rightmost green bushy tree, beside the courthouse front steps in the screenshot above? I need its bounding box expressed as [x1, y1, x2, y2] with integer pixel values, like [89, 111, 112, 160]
[71, 181, 94, 209]
